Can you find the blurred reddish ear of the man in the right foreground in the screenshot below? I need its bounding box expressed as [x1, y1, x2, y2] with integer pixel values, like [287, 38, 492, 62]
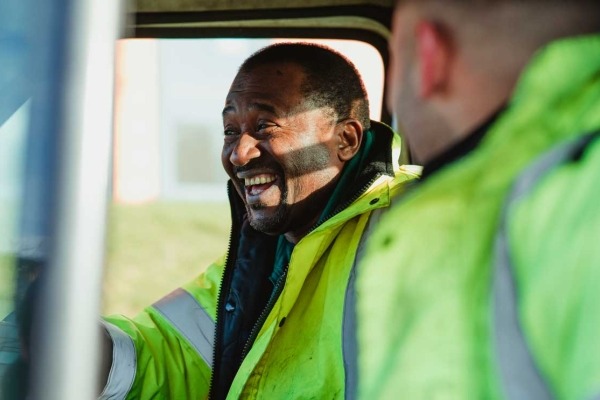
[415, 21, 452, 98]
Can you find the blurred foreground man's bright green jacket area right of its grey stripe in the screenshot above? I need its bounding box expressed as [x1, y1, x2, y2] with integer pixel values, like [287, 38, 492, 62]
[509, 140, 600, 399]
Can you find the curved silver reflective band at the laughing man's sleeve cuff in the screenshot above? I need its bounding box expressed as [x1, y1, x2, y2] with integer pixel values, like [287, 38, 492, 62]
[99, 321, 137, 400]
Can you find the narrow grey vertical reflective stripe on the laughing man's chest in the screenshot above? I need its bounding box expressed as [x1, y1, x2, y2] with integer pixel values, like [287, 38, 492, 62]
[342, 208, 384, 400]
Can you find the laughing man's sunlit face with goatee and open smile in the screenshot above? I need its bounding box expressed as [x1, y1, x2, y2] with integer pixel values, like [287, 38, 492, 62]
[221, 63, 343, 241]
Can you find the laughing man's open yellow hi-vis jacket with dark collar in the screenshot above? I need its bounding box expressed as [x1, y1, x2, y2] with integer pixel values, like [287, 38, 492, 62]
[102, 124, 416, 399]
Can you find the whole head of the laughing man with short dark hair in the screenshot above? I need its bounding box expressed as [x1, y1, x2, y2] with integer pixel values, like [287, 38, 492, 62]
[222, 43, 370, 242]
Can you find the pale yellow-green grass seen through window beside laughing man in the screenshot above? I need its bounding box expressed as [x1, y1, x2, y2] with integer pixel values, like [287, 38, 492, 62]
[103, 203, 231, 316]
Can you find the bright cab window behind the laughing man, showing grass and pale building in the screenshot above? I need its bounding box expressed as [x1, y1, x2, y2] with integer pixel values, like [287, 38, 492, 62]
[104, 39, 384, 315]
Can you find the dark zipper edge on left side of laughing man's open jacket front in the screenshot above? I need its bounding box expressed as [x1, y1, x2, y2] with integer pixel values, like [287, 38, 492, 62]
[208, 185, 240, 399]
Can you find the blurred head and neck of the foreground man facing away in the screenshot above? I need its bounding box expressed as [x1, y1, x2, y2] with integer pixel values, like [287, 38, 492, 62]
[387, 0, 600, 163]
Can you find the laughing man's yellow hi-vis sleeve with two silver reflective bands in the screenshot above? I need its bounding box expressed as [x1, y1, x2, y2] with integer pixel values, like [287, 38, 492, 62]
[100, 257, 225, 399]
